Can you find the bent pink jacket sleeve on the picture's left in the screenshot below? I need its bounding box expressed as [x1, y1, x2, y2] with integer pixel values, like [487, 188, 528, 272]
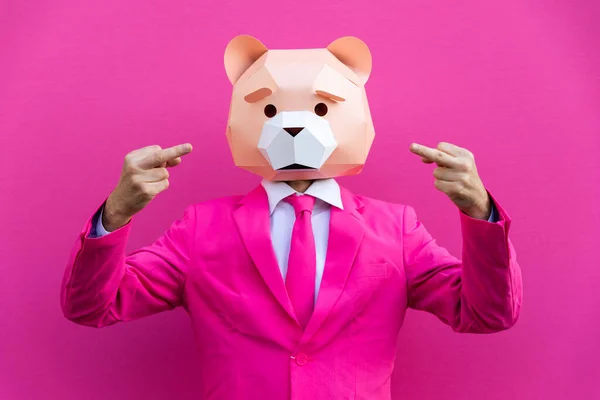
[61, 203, 195, 327]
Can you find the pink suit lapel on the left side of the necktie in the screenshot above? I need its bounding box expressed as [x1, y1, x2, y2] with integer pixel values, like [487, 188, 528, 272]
[233, 186, 298, 324]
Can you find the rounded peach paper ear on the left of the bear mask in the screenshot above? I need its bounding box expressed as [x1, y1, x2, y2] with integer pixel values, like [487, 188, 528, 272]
[225, 35, 268, 85]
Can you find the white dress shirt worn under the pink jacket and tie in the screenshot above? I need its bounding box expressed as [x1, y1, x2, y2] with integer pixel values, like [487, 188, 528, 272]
[90, 179, 344, 301]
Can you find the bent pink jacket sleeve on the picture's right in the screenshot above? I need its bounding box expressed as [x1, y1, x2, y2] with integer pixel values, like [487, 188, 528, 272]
[403, 195, 523, 333]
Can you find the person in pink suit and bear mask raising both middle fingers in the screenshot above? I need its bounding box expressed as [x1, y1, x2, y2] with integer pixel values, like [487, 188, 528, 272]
[61, 37, 522, 400]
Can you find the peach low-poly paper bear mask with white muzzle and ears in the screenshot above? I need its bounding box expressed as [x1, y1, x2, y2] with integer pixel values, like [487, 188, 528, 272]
[225, 35, 375, 181]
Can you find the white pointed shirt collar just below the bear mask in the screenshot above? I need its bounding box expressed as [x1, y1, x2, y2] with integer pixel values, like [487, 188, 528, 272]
[261, 178, 344, 214]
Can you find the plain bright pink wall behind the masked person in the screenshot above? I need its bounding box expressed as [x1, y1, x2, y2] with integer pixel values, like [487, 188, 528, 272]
[0, 0, 600, 400]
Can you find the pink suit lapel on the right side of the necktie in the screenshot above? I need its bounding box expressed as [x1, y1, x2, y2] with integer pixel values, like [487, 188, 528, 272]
[301, 189, 364, 343]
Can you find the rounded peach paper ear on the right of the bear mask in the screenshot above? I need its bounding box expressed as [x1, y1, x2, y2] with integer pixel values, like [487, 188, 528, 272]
[327, 36, 373, 85]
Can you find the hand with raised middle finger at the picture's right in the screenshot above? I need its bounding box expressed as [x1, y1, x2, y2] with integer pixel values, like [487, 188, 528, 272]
[410, 142, 492, 220]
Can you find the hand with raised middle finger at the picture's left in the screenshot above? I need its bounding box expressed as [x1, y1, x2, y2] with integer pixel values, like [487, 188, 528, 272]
[102, 143, 192, 231]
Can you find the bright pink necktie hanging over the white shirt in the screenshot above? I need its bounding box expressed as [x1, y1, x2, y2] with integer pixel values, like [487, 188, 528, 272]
[285, 194, 317, 327]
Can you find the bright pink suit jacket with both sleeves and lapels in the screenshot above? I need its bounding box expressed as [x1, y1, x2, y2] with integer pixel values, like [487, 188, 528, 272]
[61, 186, 522, 400]
